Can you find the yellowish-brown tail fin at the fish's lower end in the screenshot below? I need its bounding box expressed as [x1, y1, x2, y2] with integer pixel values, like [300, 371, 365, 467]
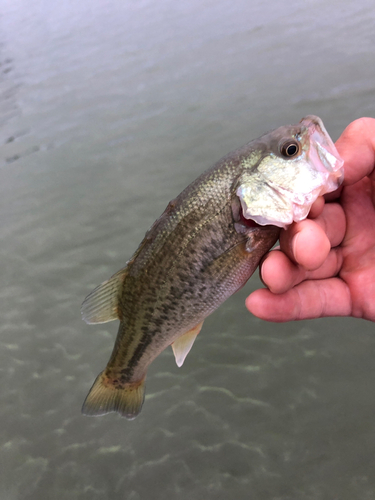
[82, 371, 146, 420]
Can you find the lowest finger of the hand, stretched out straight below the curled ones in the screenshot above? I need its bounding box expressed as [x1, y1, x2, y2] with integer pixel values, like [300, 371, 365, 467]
[246, 278, 352, 322]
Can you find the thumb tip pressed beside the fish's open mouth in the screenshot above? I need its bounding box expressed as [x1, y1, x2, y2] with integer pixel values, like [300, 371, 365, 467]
[336, 118, 375, 185]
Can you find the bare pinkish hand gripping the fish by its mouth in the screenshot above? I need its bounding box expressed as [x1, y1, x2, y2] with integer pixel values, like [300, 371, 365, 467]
[246, 118, 375, 322]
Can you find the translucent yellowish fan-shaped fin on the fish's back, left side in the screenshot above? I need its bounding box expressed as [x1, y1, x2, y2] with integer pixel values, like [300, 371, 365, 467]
[81, 267, 127, 325]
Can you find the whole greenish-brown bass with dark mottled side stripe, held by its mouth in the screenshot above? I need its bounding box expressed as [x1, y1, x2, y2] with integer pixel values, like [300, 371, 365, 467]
[81, 115, 343, 420]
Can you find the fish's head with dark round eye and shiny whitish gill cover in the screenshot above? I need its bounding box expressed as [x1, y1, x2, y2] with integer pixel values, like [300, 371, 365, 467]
[236, 115, 344, 228]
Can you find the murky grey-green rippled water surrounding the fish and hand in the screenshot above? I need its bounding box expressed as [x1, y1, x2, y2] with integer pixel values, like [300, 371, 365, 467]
[0, 0, 375, 500]
